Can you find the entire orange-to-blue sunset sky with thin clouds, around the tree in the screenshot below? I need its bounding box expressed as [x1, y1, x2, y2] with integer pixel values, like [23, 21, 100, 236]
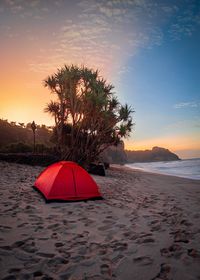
[0, 0, 200, 158]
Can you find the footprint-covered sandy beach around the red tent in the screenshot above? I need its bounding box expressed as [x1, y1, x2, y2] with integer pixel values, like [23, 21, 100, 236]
[0, 162, 200, 280]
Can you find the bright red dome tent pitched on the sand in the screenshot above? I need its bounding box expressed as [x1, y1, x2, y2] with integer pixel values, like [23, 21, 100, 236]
[34, 161, 101, 200]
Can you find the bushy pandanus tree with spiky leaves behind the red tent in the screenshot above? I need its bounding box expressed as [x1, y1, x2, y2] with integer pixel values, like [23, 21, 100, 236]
[44, 65, 133, 165]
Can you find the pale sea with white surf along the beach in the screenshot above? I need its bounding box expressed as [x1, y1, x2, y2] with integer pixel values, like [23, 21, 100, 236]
[126, 158, 200, 180]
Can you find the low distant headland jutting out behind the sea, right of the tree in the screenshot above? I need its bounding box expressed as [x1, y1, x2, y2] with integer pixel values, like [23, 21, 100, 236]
[125, 147, 180, 163]
